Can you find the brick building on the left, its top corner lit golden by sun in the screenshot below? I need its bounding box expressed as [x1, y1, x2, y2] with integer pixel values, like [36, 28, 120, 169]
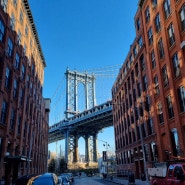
[0, 0, 50, 184]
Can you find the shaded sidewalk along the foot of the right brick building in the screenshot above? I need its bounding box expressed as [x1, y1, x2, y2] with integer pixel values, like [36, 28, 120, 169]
[103, 177, 150, 185]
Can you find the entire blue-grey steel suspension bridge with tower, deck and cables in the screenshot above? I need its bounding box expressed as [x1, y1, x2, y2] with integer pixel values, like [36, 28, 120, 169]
[49, 65, 120, 163]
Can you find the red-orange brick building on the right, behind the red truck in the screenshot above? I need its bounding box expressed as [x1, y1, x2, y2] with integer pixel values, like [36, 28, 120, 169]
[112, 0, 185, 177]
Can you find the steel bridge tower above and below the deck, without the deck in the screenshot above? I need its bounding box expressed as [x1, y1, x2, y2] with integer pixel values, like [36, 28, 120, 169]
[65, 68, 97, 162]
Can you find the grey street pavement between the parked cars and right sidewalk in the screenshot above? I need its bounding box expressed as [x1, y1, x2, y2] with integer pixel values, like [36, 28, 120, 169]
[74, 176, 118, 185]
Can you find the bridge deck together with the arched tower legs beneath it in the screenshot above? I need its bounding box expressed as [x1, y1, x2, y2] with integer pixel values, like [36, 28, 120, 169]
[49, 101, 113, 162]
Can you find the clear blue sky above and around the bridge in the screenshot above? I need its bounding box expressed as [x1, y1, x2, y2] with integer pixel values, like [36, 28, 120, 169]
[29, 0, 138, 156]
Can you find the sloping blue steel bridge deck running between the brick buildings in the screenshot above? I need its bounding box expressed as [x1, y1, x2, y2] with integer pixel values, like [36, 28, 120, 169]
[49, 101, 113, 143]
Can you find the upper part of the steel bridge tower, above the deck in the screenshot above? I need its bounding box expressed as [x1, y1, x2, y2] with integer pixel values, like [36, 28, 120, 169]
[65, 68, 96, 118]
